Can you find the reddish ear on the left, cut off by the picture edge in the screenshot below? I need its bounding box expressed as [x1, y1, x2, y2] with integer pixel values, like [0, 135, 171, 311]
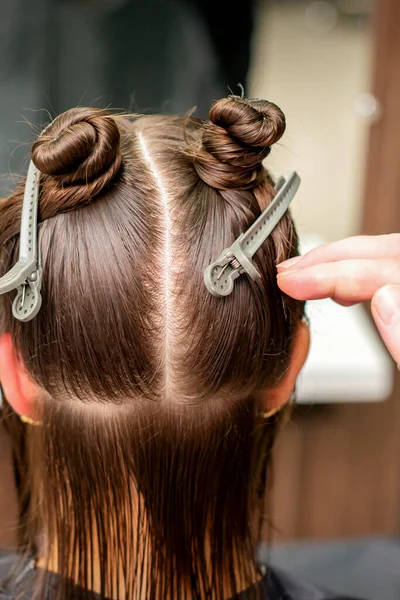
[0, 333, 40, 420]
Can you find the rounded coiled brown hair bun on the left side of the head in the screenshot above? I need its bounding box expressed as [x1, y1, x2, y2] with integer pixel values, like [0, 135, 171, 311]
[31, 108, 121, 208]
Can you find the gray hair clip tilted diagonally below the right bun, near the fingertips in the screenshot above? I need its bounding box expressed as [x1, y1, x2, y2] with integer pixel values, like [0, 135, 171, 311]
[204, 173, 300, 296]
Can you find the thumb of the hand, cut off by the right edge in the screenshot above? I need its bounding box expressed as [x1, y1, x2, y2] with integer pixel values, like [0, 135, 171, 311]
[371, 285, 400, 364]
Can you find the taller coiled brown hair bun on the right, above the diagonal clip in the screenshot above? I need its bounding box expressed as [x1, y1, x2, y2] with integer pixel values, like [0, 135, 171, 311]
[194, 96, 286, 189]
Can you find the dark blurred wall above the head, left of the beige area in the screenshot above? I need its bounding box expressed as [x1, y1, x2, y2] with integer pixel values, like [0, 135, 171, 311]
[0, 0, 253, 188]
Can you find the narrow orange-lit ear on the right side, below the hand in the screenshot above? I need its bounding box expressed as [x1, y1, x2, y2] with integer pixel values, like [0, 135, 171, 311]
[262, 321, 310, 411]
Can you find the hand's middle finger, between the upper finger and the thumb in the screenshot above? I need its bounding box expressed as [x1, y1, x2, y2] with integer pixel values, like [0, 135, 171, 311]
[277, 259, 400, 303]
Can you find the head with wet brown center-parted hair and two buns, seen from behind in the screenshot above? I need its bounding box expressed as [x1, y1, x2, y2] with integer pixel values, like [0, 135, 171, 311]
[0, 97, 307, 600]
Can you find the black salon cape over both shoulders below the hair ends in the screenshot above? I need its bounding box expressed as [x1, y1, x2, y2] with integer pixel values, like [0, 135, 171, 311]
[0, 554, 360, 600]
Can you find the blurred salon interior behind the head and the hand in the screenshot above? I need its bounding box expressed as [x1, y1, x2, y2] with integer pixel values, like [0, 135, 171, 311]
[0, 0, 400, 598]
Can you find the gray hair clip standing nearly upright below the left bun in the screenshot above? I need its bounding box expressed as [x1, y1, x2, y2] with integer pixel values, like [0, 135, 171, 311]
[0, 161, 42, 322]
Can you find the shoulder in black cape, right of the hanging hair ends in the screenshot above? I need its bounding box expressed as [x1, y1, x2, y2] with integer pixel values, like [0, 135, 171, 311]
[261, 568, 362, 600]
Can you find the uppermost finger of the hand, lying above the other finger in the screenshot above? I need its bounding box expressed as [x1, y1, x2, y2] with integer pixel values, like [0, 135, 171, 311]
[277, 233, 400, 272]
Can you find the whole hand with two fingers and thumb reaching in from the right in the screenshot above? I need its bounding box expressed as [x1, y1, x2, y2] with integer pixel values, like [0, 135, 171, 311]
[278, 233, 400, 364]
